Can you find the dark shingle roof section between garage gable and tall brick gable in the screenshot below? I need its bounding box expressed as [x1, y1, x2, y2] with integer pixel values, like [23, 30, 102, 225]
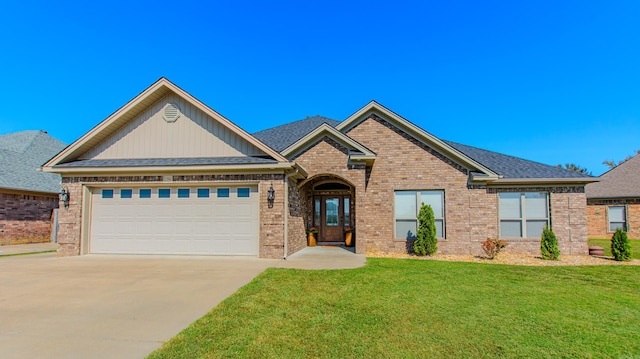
[253, 116, 340, 152]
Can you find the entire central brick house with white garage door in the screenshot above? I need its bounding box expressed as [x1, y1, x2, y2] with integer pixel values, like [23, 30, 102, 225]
[43, 78, 594, 258]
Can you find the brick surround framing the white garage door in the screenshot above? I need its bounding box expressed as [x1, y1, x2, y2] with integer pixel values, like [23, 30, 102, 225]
[58, 174, 285, 258]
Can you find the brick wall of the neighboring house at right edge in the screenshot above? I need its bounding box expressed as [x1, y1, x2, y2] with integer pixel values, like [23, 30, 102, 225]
[587, 198, 640, 239]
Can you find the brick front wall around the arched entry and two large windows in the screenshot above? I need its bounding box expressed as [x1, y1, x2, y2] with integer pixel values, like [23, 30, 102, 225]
[294, 115, 587, 255]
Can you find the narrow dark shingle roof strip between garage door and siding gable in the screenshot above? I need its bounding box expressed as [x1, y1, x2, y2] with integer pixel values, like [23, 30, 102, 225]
[55, 157, 278, 168]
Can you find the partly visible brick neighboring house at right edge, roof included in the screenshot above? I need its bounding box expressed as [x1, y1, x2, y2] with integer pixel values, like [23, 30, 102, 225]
[587, 155, 640, 239]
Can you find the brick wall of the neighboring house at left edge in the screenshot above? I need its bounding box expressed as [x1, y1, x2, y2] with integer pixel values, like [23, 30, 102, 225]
[0, 192, 58, 245]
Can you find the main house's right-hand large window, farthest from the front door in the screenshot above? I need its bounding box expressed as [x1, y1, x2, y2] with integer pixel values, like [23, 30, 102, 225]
[499, 192, 549, 238]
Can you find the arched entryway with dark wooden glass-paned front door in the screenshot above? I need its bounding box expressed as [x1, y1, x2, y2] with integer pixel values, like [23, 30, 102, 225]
[305, 175, 356, 245]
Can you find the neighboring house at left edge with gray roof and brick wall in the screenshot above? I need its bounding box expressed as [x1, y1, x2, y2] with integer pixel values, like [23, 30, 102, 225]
[0, 131, 66, 245]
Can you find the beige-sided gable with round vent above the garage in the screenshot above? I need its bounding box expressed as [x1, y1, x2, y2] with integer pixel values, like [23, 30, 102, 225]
[44, 78, 286, 170]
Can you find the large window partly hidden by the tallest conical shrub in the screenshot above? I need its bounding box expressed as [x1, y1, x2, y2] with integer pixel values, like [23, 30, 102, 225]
[395, 190, 445, 239]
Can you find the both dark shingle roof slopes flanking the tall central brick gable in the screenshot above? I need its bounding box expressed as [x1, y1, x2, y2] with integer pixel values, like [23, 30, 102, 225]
[253, 116, 591, 179]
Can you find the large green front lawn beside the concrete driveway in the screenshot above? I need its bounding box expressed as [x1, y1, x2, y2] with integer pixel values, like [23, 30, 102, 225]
[149, 259, 640, 358]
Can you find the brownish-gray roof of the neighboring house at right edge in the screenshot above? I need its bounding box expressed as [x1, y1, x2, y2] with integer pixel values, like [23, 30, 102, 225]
[586, 155, 640, 198]
